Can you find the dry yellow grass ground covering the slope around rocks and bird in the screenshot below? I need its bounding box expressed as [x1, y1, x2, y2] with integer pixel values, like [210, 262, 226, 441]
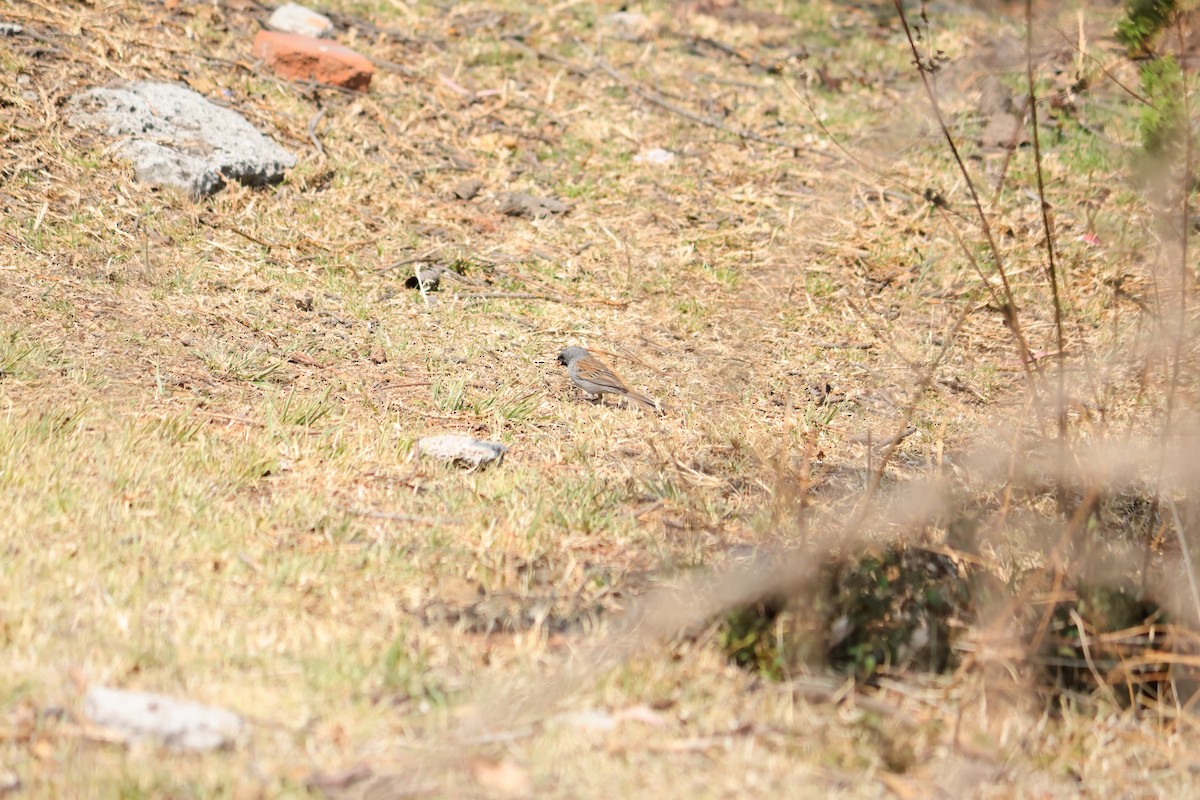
[0, 0, 1198, 798]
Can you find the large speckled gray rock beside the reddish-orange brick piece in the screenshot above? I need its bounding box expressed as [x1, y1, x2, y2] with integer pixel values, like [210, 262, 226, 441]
[67, 82, 296, 196]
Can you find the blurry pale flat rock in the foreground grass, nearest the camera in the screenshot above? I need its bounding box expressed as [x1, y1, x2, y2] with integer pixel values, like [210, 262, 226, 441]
[83, 686, 246, 750]
